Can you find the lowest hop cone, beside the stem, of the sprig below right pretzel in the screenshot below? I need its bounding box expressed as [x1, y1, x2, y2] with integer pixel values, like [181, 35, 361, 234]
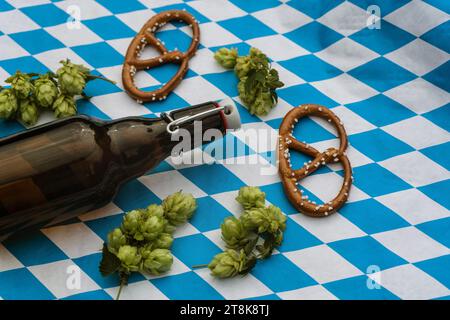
[208, 249, 247, 278]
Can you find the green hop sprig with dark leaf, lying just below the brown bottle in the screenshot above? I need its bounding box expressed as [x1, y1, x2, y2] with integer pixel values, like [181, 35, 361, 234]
[100, 192, 197, 297]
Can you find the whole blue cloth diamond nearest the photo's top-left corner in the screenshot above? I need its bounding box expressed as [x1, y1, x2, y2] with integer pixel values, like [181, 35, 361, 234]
[20, 3, 69, 28]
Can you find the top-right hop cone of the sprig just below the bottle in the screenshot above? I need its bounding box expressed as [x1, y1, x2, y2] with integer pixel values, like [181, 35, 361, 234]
[162, 191, 197, 226]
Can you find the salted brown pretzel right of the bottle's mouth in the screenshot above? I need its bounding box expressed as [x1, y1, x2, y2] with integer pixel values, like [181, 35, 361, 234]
[278, 104, 353, 217]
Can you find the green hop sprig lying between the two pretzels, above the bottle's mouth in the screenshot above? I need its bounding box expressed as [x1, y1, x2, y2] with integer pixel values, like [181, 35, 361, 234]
[214, 47, 284, 116]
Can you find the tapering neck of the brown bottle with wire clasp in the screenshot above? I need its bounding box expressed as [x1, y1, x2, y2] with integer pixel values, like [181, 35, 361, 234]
[106, 102, 226, 177]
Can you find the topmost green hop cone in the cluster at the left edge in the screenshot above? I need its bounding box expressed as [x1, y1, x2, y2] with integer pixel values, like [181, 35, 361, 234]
[56, 59, 89, 96]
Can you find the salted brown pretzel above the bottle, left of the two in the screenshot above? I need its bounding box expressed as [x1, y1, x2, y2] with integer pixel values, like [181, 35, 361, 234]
[122, 10, 200, 103]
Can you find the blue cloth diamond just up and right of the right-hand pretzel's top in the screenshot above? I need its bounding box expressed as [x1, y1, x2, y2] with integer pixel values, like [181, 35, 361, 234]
[346, 94, 416, 127]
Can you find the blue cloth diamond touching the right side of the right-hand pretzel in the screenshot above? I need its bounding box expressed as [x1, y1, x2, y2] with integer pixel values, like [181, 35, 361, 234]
[350, 163, 412, 197]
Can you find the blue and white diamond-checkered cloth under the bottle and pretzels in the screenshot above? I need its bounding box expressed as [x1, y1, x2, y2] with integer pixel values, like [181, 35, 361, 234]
[0, 0, 450, 299]
